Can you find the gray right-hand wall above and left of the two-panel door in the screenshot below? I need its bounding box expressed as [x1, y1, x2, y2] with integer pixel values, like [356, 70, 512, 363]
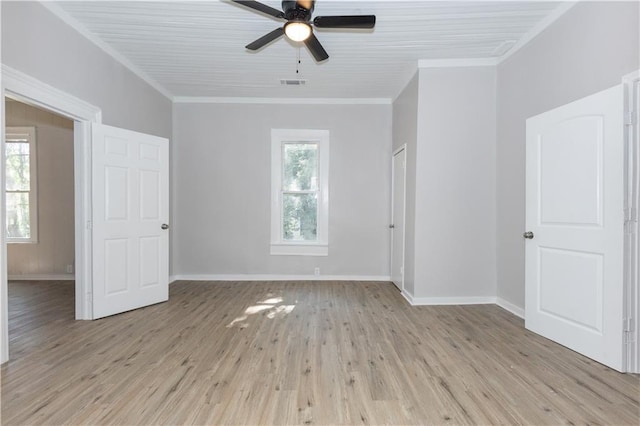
[497, 2, 640, 308]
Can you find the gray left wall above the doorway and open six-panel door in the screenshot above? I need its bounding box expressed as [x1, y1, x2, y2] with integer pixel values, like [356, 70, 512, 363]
[2, 2, 171, 138]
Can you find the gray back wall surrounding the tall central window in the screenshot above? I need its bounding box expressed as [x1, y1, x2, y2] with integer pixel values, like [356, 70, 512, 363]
[172, 104, 392, 277]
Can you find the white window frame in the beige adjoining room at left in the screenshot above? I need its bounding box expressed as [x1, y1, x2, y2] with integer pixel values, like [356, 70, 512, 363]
[2, 126, 38, 244]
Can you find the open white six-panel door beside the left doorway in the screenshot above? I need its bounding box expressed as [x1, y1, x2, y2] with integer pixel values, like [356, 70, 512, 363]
[92, 124, 169, 318]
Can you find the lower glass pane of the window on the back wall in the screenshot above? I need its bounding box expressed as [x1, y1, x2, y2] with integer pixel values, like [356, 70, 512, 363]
[282, 194, 318, 241]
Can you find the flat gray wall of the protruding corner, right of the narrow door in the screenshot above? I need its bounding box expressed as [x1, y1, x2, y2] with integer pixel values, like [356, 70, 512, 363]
[414, 67, 496, 298]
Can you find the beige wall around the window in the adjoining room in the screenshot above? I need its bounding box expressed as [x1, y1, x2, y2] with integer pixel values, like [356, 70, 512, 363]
[5, 101, 75, 277]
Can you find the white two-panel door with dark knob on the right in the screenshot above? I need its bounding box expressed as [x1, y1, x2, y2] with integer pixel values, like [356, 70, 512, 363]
[525, 86, 624, 371]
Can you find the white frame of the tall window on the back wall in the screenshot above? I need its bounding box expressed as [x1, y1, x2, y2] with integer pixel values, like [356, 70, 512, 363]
[270, 129, 329, 256]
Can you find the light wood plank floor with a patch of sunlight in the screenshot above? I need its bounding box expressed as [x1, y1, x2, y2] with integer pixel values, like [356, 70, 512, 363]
[2, 282, 640, 425]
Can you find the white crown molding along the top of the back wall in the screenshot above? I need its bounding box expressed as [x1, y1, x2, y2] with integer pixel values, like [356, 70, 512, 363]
[173, 96, 392, 105]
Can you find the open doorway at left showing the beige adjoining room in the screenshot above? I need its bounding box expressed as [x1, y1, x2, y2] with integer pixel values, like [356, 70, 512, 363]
[3, 98, 75, 358]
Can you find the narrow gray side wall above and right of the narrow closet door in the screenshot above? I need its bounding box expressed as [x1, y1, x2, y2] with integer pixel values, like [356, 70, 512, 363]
[392, 72, 419, 295]
